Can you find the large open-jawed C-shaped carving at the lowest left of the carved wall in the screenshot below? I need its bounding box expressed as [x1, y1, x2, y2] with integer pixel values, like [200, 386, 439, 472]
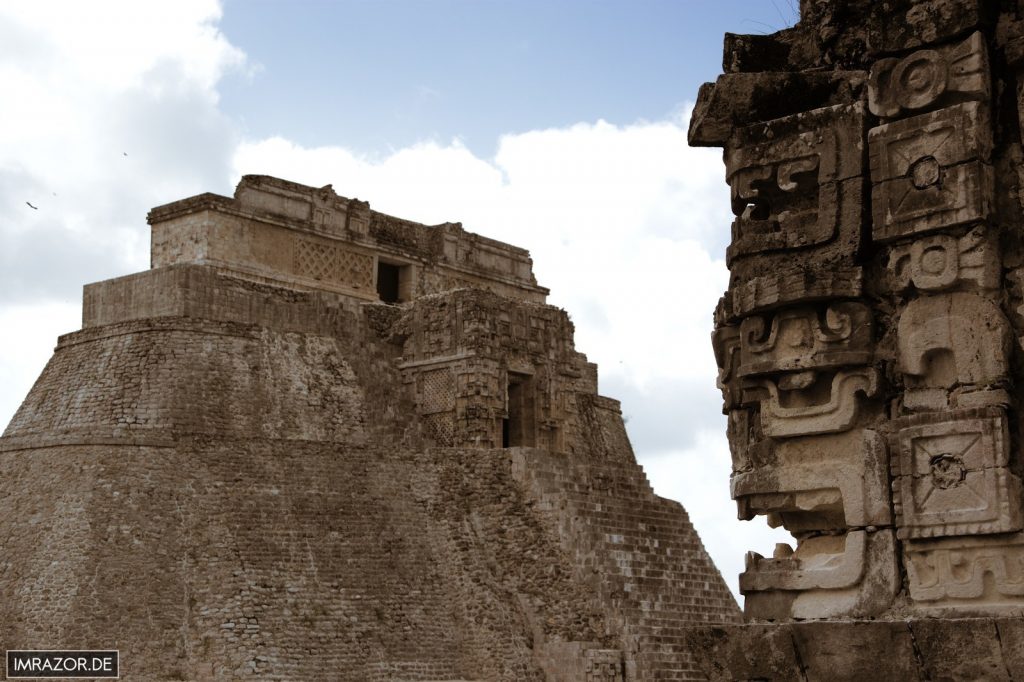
[730, 419, 899, 620]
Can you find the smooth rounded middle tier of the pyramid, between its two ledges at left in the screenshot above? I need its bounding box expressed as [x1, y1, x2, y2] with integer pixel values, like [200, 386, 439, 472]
[4, 317, 366, 442]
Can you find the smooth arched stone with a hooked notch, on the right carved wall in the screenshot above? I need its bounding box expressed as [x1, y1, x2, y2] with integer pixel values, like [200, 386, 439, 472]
[897, 293, 1012, 388]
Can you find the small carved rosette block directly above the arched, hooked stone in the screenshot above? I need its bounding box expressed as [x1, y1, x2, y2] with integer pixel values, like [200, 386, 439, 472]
[889, 225, 1001, 292]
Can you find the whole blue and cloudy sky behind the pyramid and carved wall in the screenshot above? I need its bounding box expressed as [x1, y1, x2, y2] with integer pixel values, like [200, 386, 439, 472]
[0, 0, 797, 592]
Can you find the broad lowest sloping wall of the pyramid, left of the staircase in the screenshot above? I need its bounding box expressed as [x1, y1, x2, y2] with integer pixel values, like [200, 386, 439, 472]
[0, 437, 622, 682]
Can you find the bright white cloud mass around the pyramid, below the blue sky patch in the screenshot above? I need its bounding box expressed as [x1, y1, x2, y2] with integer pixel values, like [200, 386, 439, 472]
[0, 0, 764, 598]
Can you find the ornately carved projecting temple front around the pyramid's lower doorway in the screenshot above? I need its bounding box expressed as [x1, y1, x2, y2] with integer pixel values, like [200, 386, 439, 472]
[393, 289, 598, 453]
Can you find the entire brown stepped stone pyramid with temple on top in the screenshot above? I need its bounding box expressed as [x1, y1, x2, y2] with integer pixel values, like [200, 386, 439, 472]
[0, 176, 737, 682]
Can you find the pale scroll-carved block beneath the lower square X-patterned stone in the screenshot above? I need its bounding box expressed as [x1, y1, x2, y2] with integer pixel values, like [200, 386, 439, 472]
[903, 536, 1024, 608]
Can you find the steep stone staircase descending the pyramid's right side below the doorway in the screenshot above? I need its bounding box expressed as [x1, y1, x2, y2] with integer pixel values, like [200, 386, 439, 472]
[513, 449, 739, 682]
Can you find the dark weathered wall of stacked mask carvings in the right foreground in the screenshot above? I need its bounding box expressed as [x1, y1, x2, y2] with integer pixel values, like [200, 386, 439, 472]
[689, 0, 1024, 680]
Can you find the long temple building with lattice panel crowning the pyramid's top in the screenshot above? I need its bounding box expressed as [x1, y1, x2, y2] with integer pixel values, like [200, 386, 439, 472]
[148, 175, 548, 303]
